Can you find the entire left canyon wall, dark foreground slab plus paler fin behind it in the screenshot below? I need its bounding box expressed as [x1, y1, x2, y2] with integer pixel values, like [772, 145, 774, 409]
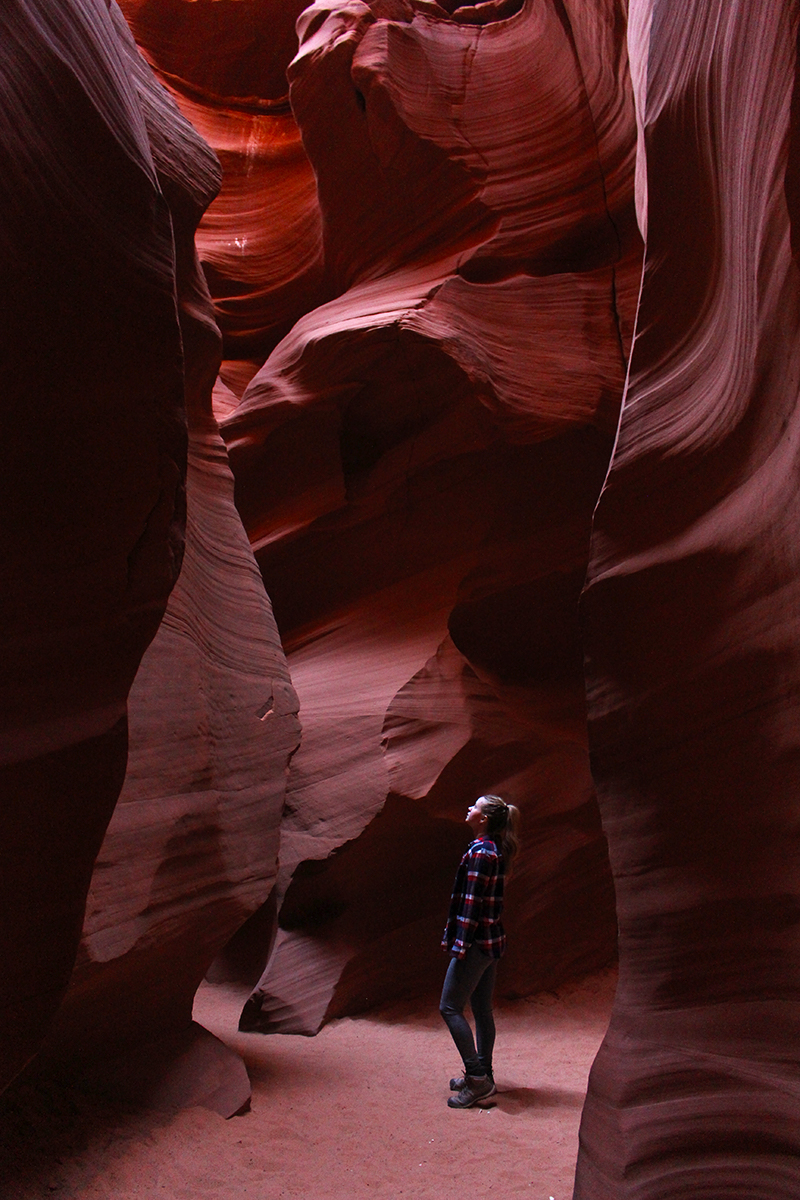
[0, 0, 297, 1111]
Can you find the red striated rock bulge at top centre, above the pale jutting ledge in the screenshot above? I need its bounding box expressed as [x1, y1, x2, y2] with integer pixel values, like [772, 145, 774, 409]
[289, 0, 637, 292]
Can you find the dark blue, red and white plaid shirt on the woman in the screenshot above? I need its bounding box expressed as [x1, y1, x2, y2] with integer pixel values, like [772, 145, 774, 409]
[441, 838, 506, 959]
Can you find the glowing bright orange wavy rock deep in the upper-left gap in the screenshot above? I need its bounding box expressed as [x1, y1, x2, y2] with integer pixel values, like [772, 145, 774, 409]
[121, 0, 326, 355]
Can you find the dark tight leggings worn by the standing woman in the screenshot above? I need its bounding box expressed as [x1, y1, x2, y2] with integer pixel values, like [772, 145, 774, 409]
[439, 946, 498, 1075]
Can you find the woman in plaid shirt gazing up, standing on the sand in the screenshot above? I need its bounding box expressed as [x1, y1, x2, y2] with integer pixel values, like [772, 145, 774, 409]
[439, 796, 519, 1109]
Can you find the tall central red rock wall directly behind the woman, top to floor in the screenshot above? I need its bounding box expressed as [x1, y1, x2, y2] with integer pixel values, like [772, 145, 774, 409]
[220, 0, 640, 1033]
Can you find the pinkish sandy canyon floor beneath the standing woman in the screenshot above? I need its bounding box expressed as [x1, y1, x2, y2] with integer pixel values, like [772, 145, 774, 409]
[0, 970, 615, 1200]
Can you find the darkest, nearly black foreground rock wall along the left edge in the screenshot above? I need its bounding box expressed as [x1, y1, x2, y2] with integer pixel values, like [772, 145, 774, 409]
[0, 0, 209, 1099]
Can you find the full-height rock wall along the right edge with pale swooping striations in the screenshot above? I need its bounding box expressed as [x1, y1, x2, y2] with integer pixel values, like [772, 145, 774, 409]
[576, 0, 800, 1200]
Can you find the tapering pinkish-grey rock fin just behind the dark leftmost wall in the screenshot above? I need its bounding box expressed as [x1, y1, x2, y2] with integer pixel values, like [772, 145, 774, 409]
[24, 17, 299, 1116]
